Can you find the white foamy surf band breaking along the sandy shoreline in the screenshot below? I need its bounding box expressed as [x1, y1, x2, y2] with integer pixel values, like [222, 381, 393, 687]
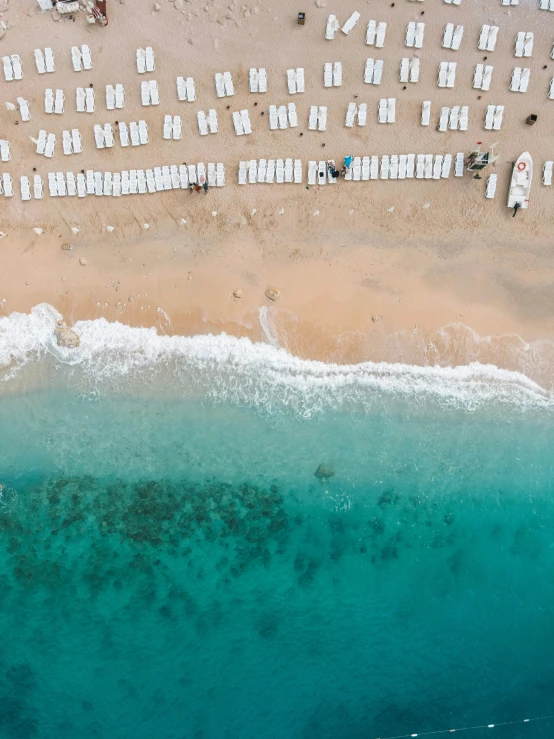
[0, 304, 554, 416]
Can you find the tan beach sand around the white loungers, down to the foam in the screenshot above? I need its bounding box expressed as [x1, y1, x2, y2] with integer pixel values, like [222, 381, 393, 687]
[0, 0, 554, 386]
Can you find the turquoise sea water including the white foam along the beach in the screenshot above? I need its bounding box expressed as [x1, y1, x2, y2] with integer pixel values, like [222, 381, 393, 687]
[0, 306, 554, 739]
